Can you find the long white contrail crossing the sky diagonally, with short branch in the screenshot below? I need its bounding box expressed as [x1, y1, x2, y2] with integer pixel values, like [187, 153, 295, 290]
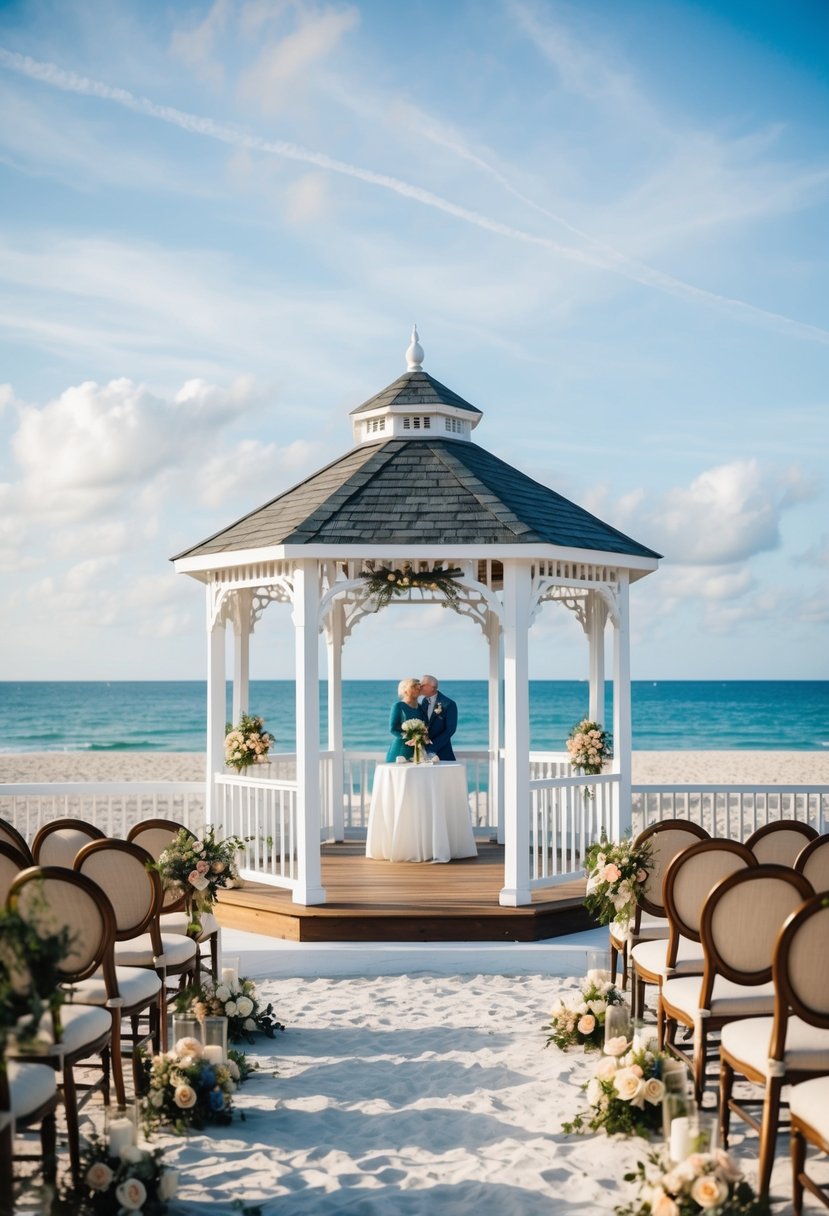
[0, 47, 829, 343]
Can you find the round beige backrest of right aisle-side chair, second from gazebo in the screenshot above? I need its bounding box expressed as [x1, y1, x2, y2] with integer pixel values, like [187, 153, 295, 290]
[662, 838, 757, 964]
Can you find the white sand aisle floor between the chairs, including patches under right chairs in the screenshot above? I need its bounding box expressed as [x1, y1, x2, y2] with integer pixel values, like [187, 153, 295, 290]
[69, 974, 811, 1216]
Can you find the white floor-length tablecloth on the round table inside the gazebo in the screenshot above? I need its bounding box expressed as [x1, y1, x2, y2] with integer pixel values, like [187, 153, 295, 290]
[366, 761, 478, 861]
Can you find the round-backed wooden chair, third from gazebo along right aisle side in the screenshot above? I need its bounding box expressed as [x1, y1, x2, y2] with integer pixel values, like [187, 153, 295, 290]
[659, 866, 813, 1105]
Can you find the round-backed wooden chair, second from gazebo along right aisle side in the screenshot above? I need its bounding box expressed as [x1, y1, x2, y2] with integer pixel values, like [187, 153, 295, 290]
[631, 839, 756, 1026]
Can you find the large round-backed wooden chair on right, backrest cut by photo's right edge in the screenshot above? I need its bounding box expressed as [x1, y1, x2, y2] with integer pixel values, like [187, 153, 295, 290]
[720, 890, 829, 1195]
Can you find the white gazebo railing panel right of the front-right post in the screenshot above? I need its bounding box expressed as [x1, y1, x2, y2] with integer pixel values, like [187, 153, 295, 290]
[530, 765, 619, 890]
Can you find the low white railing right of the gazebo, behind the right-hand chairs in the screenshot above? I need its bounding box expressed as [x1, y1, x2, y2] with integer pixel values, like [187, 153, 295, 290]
[631, 786, 829, 840]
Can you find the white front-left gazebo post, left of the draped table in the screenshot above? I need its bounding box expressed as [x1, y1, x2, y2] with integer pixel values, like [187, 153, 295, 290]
[293, 558, 326, 905]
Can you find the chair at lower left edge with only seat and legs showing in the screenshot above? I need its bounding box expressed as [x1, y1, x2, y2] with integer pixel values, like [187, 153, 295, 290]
[0, 1059, 58, 1216]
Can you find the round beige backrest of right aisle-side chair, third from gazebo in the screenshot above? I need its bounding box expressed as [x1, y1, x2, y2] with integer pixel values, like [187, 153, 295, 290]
[700, 866, 813, 996]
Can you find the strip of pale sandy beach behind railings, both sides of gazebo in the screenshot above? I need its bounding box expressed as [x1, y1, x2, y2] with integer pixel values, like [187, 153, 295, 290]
[0, 748, 829, 786]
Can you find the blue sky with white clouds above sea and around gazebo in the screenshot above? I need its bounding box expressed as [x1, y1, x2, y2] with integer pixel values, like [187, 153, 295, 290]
[0, 0, 829, 680]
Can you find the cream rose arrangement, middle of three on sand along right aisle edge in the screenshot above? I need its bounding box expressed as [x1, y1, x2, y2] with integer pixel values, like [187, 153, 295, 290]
[562, 1037, 670, 1136]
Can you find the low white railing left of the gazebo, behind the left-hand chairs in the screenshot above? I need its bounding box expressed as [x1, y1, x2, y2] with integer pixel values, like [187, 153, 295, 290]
[0, 781, 205, 843]
